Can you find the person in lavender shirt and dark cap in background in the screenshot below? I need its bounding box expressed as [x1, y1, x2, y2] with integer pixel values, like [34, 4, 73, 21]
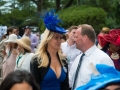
[23, 26, 39, 53]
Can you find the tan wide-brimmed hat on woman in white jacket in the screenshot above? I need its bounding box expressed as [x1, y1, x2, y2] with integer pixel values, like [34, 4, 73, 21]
[16, 36, 31, 51]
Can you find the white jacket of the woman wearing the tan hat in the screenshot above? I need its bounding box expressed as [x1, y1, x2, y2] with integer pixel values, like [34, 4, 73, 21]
[14, 53, 34, 72]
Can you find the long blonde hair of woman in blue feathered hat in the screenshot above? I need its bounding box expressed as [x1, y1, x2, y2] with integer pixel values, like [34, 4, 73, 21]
[36, 29, 66, 68]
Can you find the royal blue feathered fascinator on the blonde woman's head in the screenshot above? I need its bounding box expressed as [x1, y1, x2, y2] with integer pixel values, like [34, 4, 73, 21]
[41, 10, 66, 34]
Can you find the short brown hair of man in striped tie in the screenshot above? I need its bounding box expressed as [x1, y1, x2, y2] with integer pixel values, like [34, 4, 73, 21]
[78, 24, 96, 43]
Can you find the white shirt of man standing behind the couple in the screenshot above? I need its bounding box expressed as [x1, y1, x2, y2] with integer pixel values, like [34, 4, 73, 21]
[61, 41, 81, 70]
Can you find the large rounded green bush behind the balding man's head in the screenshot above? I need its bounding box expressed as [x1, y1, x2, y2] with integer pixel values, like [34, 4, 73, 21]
[59, 6, 107, 30]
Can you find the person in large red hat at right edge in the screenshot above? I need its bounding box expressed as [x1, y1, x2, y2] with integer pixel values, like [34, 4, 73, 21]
[99, 29, 120, 71]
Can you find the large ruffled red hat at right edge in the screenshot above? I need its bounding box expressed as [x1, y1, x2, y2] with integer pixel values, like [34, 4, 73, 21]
[98, 29, 120, 47]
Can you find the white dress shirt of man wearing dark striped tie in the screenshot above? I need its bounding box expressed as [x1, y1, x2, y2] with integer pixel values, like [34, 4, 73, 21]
[69, 45, 114, 88]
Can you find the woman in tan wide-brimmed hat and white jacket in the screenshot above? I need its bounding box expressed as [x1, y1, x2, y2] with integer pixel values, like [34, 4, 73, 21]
[15, 37, 34, 72]
